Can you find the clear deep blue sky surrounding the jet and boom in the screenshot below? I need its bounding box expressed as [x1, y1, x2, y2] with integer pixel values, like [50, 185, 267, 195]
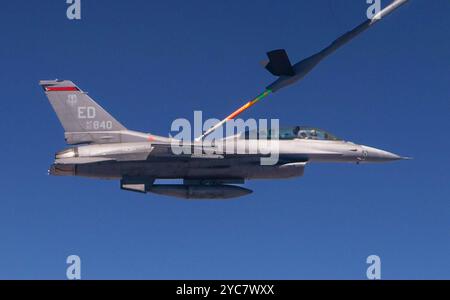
[0, 0, 450, 279]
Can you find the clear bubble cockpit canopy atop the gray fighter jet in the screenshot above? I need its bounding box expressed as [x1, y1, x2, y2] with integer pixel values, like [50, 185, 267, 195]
[241, 126, 341, 141]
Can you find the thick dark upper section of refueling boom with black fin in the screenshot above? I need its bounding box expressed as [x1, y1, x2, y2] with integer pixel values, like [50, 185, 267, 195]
[265, 0, 408, 92]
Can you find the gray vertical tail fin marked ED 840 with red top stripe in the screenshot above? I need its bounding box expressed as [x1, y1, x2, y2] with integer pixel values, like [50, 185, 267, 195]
[39, 80, 126, 144]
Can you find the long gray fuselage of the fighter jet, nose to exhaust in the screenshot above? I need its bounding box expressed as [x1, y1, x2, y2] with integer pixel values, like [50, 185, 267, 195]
[50, 138, 401, 179]
